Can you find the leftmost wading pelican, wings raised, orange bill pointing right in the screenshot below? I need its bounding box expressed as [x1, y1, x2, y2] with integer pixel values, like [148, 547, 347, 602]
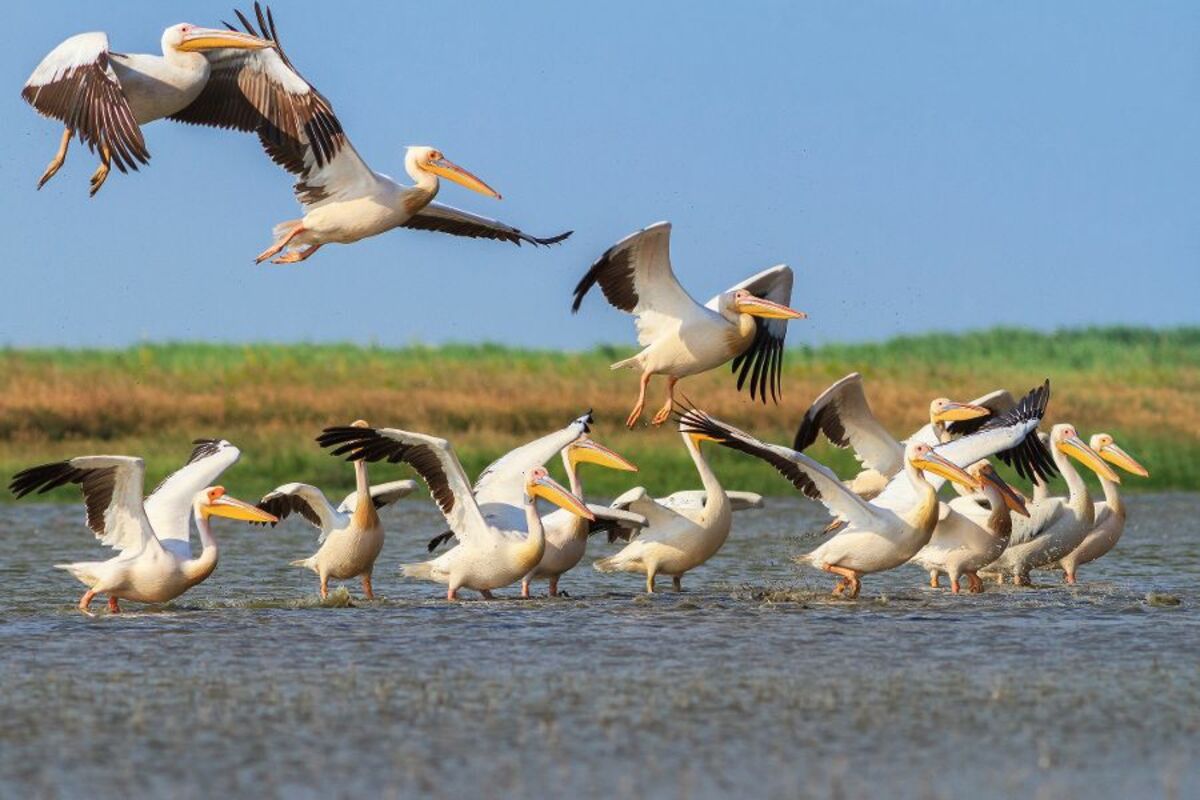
[8, 456, 275, 615]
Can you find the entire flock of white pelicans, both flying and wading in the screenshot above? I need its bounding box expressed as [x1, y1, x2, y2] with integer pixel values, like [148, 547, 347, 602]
[10, 4, 1147, 613]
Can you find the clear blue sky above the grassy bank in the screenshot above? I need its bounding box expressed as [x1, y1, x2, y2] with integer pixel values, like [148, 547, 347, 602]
[0, 0, 1200, 349]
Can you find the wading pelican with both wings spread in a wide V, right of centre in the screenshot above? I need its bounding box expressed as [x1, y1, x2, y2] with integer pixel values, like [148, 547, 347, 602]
[684, 381, 1050, 597]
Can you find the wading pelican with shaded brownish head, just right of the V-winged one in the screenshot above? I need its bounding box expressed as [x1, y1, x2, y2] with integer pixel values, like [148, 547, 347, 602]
[912, 461, 1030, 594]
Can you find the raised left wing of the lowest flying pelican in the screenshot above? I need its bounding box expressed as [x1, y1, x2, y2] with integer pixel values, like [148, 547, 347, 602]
[571, 222, 703, 347]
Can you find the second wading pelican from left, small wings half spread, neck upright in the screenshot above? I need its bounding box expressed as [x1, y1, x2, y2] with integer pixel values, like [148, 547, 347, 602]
[258, 420, 416, 600]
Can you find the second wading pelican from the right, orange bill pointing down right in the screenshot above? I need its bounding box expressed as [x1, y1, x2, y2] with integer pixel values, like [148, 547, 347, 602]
[979, 423, 1121, 585]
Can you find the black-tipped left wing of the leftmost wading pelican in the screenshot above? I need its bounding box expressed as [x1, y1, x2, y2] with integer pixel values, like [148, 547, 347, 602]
[8, 456, 158, 552]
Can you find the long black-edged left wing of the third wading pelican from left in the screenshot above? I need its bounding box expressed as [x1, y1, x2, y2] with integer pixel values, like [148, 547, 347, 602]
[317, 426, 488, 543]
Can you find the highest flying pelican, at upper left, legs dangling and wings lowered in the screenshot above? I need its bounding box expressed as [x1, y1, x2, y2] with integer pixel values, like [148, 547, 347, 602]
[20, 23, 277, 196]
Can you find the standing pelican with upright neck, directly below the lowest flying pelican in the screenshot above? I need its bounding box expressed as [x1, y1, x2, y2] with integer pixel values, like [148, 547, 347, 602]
[593, 417, 762, 594]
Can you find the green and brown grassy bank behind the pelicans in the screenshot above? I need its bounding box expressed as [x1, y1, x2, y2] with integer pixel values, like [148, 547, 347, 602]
[0, 327, 1200, 500]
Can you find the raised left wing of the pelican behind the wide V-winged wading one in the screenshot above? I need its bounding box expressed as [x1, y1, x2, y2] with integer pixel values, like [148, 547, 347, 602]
[792, 372, 904, 477]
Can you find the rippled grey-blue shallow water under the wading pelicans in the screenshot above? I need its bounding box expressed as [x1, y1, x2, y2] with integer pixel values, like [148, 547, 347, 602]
[0, 494, 1200, 798]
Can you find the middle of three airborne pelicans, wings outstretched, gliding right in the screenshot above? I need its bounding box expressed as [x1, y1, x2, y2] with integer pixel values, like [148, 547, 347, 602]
[199, 2, 572, 264]
